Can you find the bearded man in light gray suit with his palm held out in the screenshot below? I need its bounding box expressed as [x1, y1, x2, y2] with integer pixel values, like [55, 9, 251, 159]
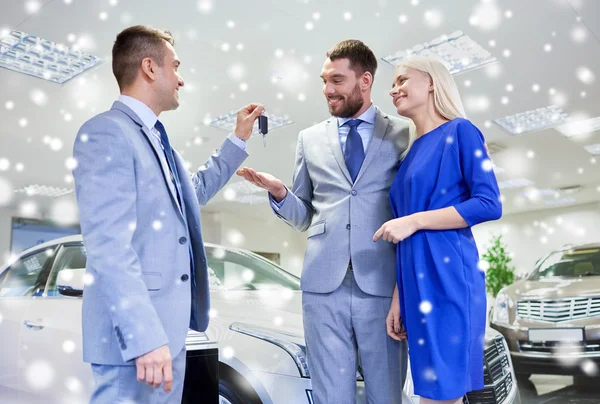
[238, 40, 408, 404]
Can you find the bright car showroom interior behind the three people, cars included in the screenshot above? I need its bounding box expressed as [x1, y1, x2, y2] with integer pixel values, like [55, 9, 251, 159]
[0, 0, 600, 404]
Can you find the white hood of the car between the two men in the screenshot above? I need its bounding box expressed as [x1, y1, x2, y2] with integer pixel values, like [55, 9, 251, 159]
[210, 291, 304, 338]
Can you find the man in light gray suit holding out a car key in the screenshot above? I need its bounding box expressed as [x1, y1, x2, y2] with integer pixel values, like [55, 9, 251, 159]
[74, 26, 263, 404]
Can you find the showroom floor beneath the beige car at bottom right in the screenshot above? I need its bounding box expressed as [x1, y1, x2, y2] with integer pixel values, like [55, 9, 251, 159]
[519, 375, 600, 404]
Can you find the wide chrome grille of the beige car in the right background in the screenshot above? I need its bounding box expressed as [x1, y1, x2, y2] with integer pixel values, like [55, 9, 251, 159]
[517, 297, 600, 323]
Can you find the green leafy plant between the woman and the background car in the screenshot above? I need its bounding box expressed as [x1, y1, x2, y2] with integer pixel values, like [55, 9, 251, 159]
[482, 235, 515, 298]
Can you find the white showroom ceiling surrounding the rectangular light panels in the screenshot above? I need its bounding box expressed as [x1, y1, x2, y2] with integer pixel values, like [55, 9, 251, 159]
[0, 0, 600, 221]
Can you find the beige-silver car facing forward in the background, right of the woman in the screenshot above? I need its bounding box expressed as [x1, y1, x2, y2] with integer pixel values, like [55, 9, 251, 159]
[491, 244, 600, 379]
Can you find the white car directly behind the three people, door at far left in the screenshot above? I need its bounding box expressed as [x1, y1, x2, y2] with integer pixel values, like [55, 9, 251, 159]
[0, 236, 520, 404]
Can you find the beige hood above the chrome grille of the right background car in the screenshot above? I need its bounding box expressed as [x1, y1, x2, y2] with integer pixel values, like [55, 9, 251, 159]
[505, 276, 600, 300]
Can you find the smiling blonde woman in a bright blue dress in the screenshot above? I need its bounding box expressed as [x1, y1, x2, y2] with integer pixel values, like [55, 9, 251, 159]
[373, 57, 502, 404]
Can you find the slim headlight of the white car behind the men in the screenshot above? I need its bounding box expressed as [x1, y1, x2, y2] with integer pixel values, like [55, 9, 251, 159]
[229, 323, 364, 381]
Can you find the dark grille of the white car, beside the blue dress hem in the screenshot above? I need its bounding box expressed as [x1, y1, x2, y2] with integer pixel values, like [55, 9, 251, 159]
[463, 336, 513, 404]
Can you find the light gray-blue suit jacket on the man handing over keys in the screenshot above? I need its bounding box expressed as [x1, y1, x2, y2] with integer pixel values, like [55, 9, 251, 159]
[73, 101, 247, 365]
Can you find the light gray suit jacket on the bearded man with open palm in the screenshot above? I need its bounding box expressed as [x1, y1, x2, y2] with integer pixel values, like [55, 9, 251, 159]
[275, 109, 408, 297]
